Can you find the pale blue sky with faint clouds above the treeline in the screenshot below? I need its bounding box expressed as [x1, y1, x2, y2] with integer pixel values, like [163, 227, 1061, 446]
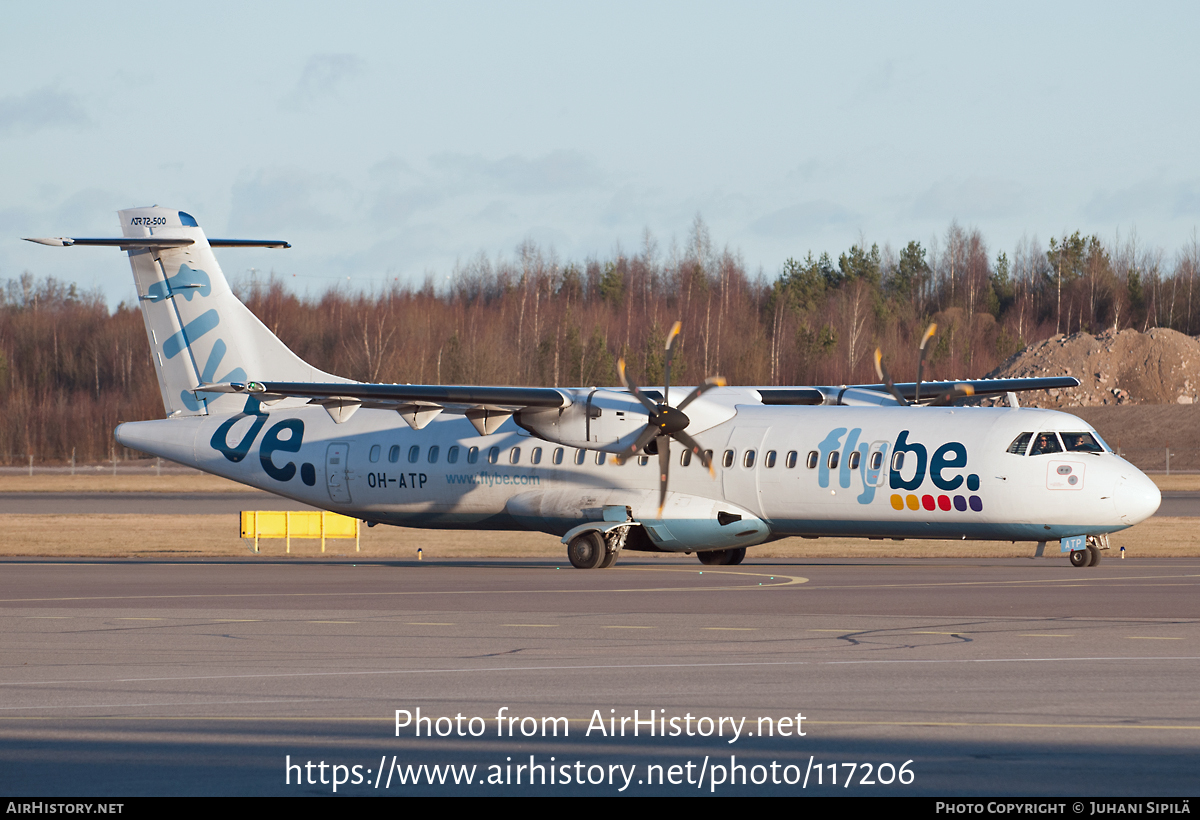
[0, 1, 1200, 305]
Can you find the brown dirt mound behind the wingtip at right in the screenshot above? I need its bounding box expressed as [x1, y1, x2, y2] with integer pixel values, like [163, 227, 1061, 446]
[988, 328, 1200, 408]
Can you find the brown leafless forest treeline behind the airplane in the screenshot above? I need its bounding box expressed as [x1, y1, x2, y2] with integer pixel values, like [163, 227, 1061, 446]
[0, 217, 1200, 465]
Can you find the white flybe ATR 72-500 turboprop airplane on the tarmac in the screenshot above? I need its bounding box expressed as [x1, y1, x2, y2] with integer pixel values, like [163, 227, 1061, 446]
[23, 207, 1162, 569]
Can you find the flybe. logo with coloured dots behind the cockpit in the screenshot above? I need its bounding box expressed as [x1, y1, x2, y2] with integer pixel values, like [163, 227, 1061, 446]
[816, 427, 983, 513]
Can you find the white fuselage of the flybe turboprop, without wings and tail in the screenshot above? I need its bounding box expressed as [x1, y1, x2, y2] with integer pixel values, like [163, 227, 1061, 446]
[116, 403, 1160, 550]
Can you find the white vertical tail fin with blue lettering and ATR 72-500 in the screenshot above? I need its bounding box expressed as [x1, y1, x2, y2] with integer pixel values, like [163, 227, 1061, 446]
[120, 208, 344, 415]
